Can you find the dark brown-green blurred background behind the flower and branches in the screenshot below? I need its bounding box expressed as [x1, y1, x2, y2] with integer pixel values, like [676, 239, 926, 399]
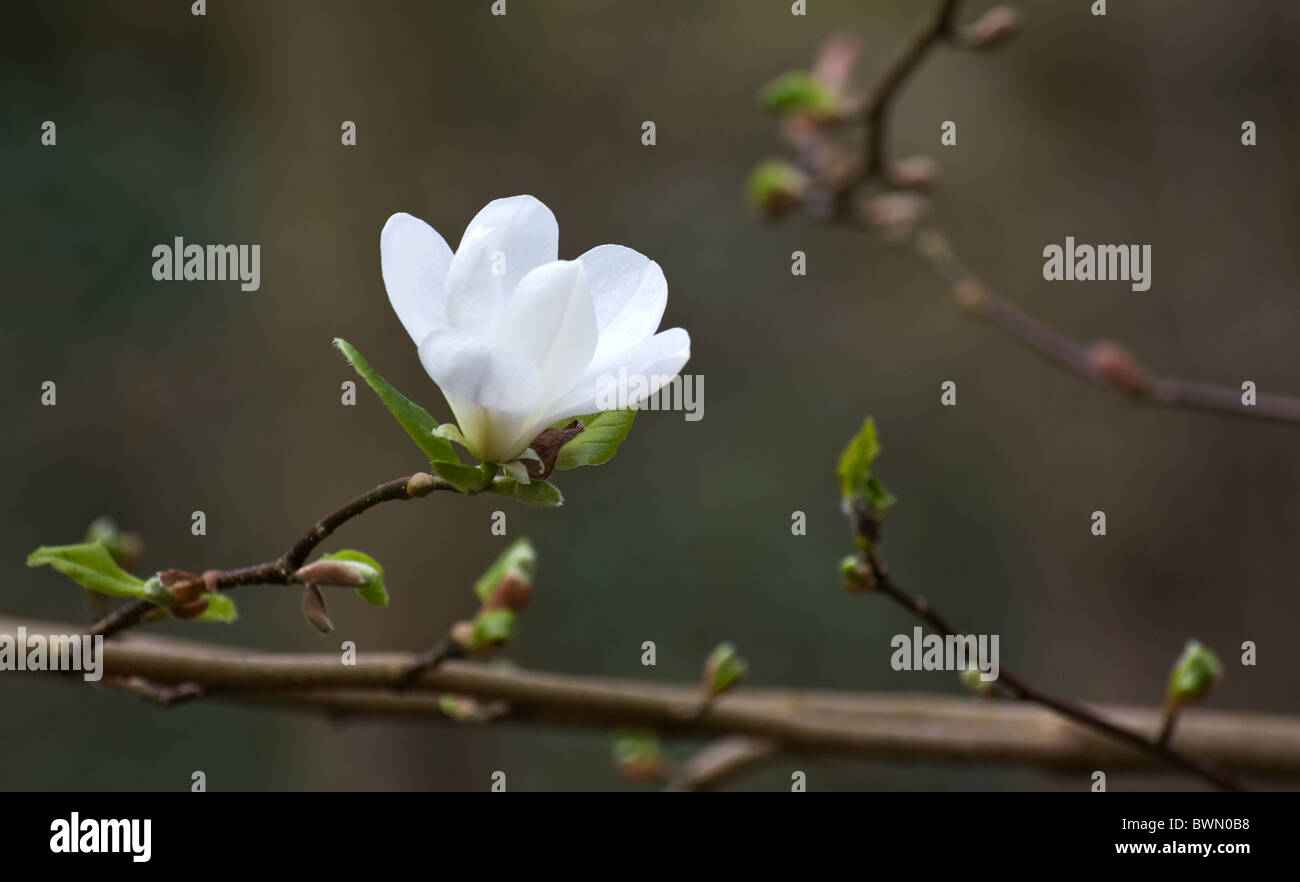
[0, 0, 1300, 790]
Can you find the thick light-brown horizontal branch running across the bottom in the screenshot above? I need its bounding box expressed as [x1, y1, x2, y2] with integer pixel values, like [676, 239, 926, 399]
[10, 617, 1300, 781]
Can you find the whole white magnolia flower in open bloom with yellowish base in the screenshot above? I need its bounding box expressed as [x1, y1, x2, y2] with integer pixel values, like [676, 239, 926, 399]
[380, 196, 690, 463]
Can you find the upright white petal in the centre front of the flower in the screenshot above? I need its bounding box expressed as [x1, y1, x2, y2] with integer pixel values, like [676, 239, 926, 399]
[495, 260, 597, 402]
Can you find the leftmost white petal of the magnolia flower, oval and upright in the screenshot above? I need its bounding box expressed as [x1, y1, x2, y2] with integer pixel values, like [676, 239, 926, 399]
[380, 213, 451, 346]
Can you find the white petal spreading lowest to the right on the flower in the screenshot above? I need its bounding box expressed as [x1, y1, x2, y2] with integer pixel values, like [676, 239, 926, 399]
[538, 328, 690, 425]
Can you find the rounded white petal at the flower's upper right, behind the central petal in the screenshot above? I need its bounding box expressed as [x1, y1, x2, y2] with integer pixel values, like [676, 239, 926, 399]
[579, 245, 668, 360]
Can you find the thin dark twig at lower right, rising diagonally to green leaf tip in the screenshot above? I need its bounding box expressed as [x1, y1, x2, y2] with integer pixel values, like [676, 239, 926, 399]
[850, 501, 1252, 791]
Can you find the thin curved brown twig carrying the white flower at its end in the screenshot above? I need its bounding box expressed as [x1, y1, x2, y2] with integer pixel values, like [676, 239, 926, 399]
[90, 472, 455, 637]
